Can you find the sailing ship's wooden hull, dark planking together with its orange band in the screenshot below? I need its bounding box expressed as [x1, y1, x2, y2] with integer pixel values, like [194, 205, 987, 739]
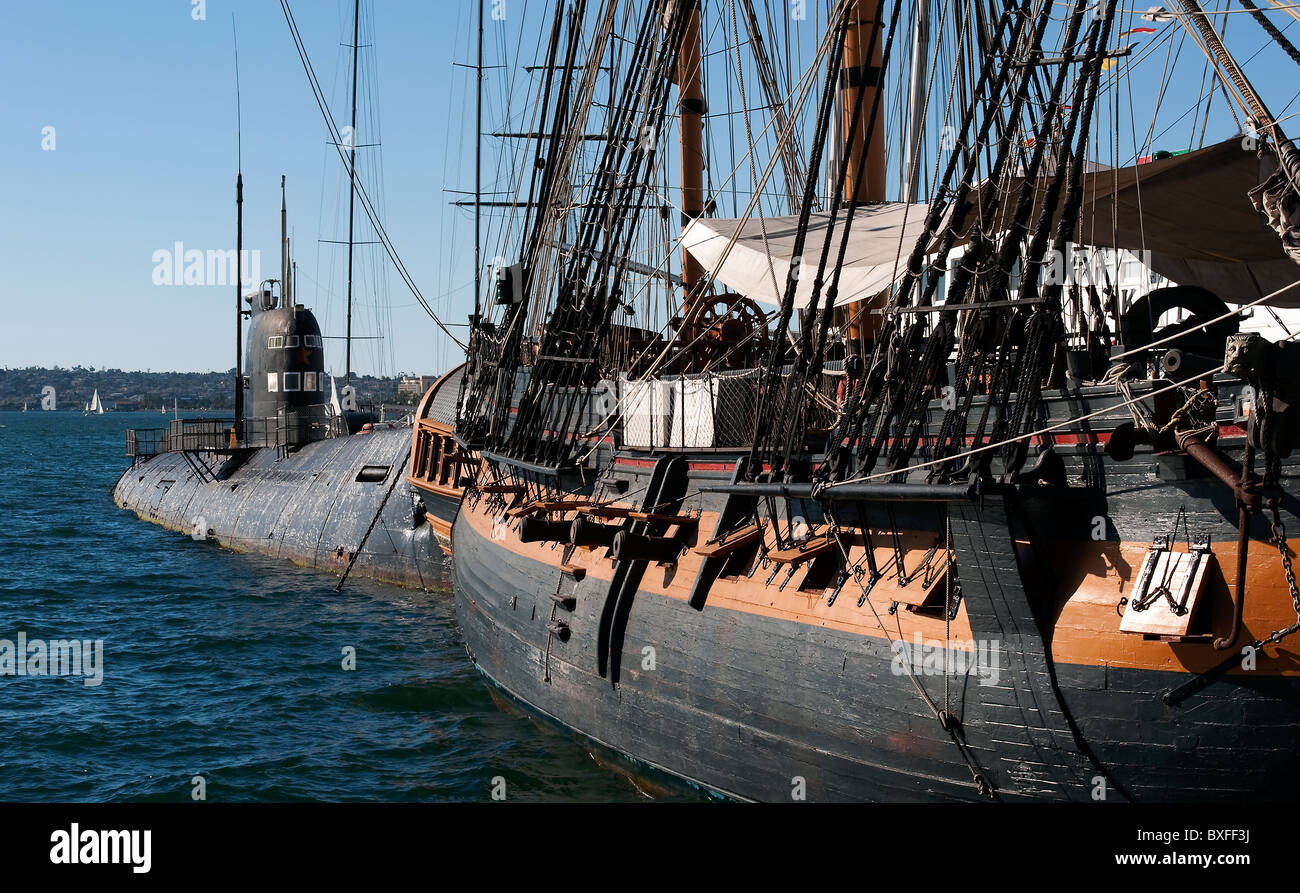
[452, 374, 1300, 802]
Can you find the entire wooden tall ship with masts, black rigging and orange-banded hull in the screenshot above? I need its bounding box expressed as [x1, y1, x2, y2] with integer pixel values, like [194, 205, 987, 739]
[452, 0, 1300, 802]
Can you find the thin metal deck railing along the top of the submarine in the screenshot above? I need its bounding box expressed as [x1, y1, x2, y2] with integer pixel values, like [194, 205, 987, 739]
[126, 416, 347, 460]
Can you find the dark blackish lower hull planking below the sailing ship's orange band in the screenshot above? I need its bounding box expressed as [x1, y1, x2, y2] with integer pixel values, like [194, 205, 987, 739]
[454, 499, 1300, 802]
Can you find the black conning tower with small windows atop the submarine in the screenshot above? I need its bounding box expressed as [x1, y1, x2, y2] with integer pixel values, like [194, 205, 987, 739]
[244, 286, 339, 446]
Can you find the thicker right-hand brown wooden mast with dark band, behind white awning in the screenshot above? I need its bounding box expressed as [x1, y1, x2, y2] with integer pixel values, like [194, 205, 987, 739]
[840, 0, 888, 354]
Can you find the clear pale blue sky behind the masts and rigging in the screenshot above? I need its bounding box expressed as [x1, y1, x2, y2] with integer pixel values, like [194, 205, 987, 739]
[0, 0, 1300, 374]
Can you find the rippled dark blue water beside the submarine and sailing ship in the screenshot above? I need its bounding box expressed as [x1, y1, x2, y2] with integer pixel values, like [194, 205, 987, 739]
[0, 412, 663, 802]
